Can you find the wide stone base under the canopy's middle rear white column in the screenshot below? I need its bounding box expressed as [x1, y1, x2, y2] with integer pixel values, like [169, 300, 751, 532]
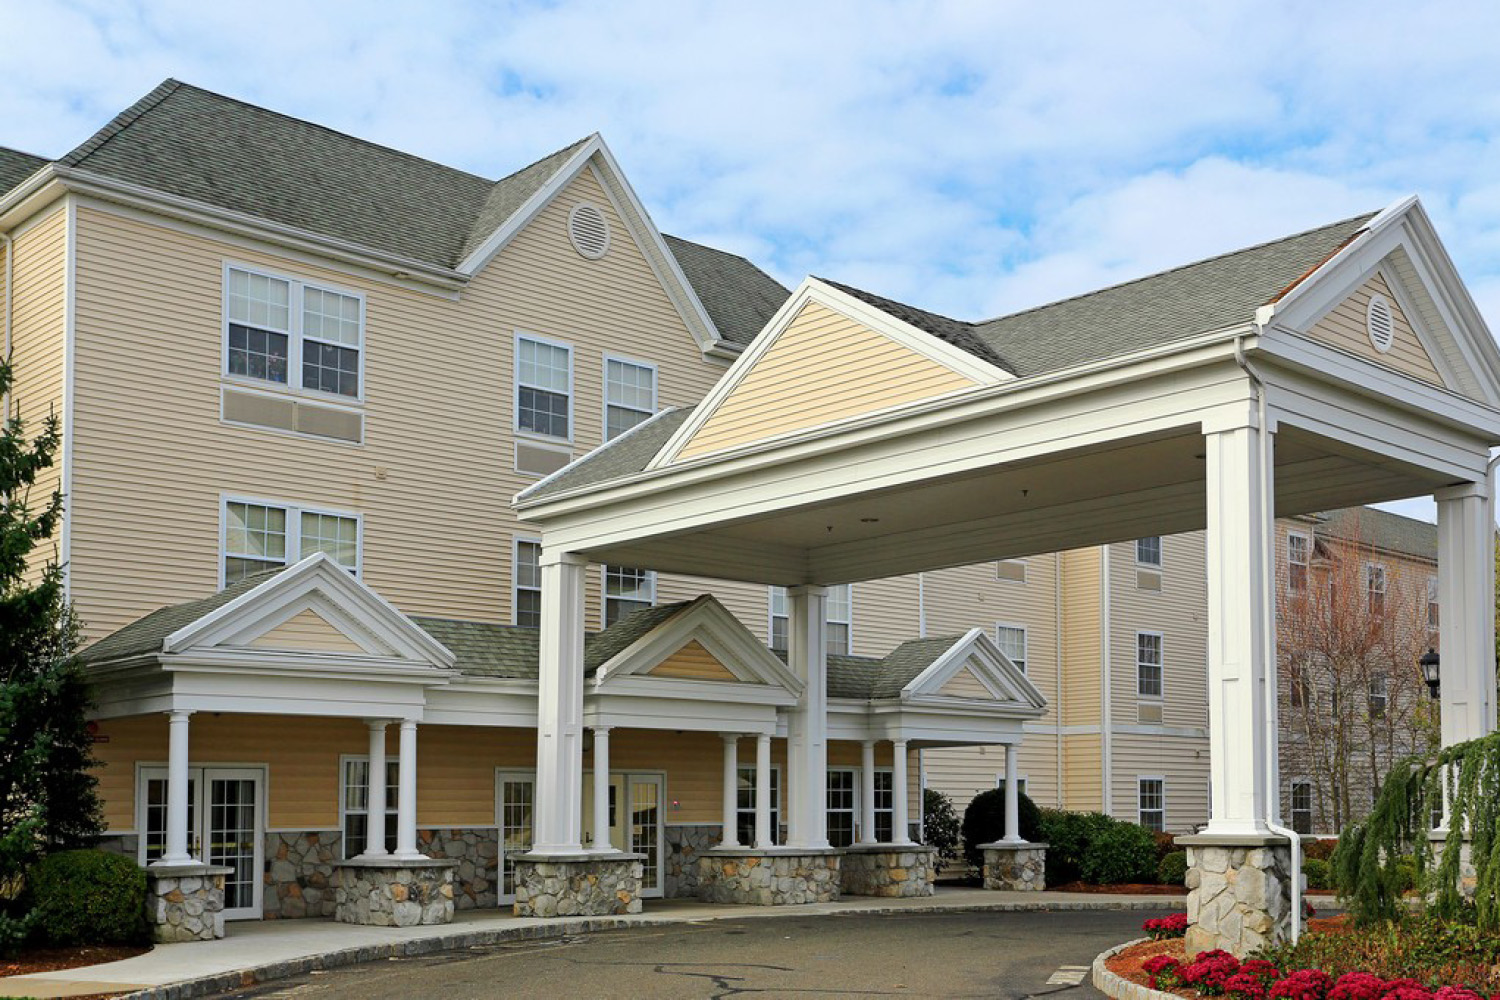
[698, 847, 840, 906]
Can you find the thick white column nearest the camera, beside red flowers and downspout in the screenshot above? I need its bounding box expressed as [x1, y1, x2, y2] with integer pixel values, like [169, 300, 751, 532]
[1205, 427, 1275, 835]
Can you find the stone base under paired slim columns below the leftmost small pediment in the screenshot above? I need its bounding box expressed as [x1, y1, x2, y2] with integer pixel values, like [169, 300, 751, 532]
[333, 858, 458, 927]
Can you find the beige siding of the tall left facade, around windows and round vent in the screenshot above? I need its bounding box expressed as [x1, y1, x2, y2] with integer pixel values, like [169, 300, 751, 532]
[74, 171, 738, 639]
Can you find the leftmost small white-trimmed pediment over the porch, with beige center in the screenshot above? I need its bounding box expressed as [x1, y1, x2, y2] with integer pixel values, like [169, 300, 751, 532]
[162, 553, 453, 669]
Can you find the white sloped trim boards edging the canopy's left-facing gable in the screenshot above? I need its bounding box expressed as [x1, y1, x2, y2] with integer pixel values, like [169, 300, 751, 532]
[647, 277, 1016, 471]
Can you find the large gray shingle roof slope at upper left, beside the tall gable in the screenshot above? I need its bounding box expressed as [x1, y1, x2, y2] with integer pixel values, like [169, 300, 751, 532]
[49, 79, 587, 268]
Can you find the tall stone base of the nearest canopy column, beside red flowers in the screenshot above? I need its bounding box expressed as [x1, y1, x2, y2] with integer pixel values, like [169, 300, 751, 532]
[1178, 834, 1301, 958]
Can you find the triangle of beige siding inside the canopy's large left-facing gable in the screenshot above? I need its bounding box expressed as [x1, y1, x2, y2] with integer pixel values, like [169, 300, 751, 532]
[678, 301, 975, 459]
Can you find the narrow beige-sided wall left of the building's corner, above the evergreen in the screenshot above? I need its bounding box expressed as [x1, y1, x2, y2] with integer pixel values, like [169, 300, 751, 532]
[0, 202, 68, 579]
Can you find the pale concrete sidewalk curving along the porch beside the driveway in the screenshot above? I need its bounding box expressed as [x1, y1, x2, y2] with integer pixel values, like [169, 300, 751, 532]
[0, 888, 1187, 1000]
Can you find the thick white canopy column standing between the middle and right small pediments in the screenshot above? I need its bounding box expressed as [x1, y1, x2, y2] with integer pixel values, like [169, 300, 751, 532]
[783, 586, 828, 850]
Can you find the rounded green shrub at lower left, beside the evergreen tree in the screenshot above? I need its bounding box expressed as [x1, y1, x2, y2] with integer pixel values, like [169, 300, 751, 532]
[27, 850, 149, 946]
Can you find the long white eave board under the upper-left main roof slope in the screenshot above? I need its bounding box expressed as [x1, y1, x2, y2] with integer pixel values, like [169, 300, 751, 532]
[46, 166, 468, 291]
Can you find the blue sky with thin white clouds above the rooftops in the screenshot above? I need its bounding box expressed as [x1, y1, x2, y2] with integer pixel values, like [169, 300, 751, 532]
[0, 0, 1500, 511]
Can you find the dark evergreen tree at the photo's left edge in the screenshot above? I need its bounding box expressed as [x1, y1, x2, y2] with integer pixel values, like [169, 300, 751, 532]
[0, 361, 101, 897]
